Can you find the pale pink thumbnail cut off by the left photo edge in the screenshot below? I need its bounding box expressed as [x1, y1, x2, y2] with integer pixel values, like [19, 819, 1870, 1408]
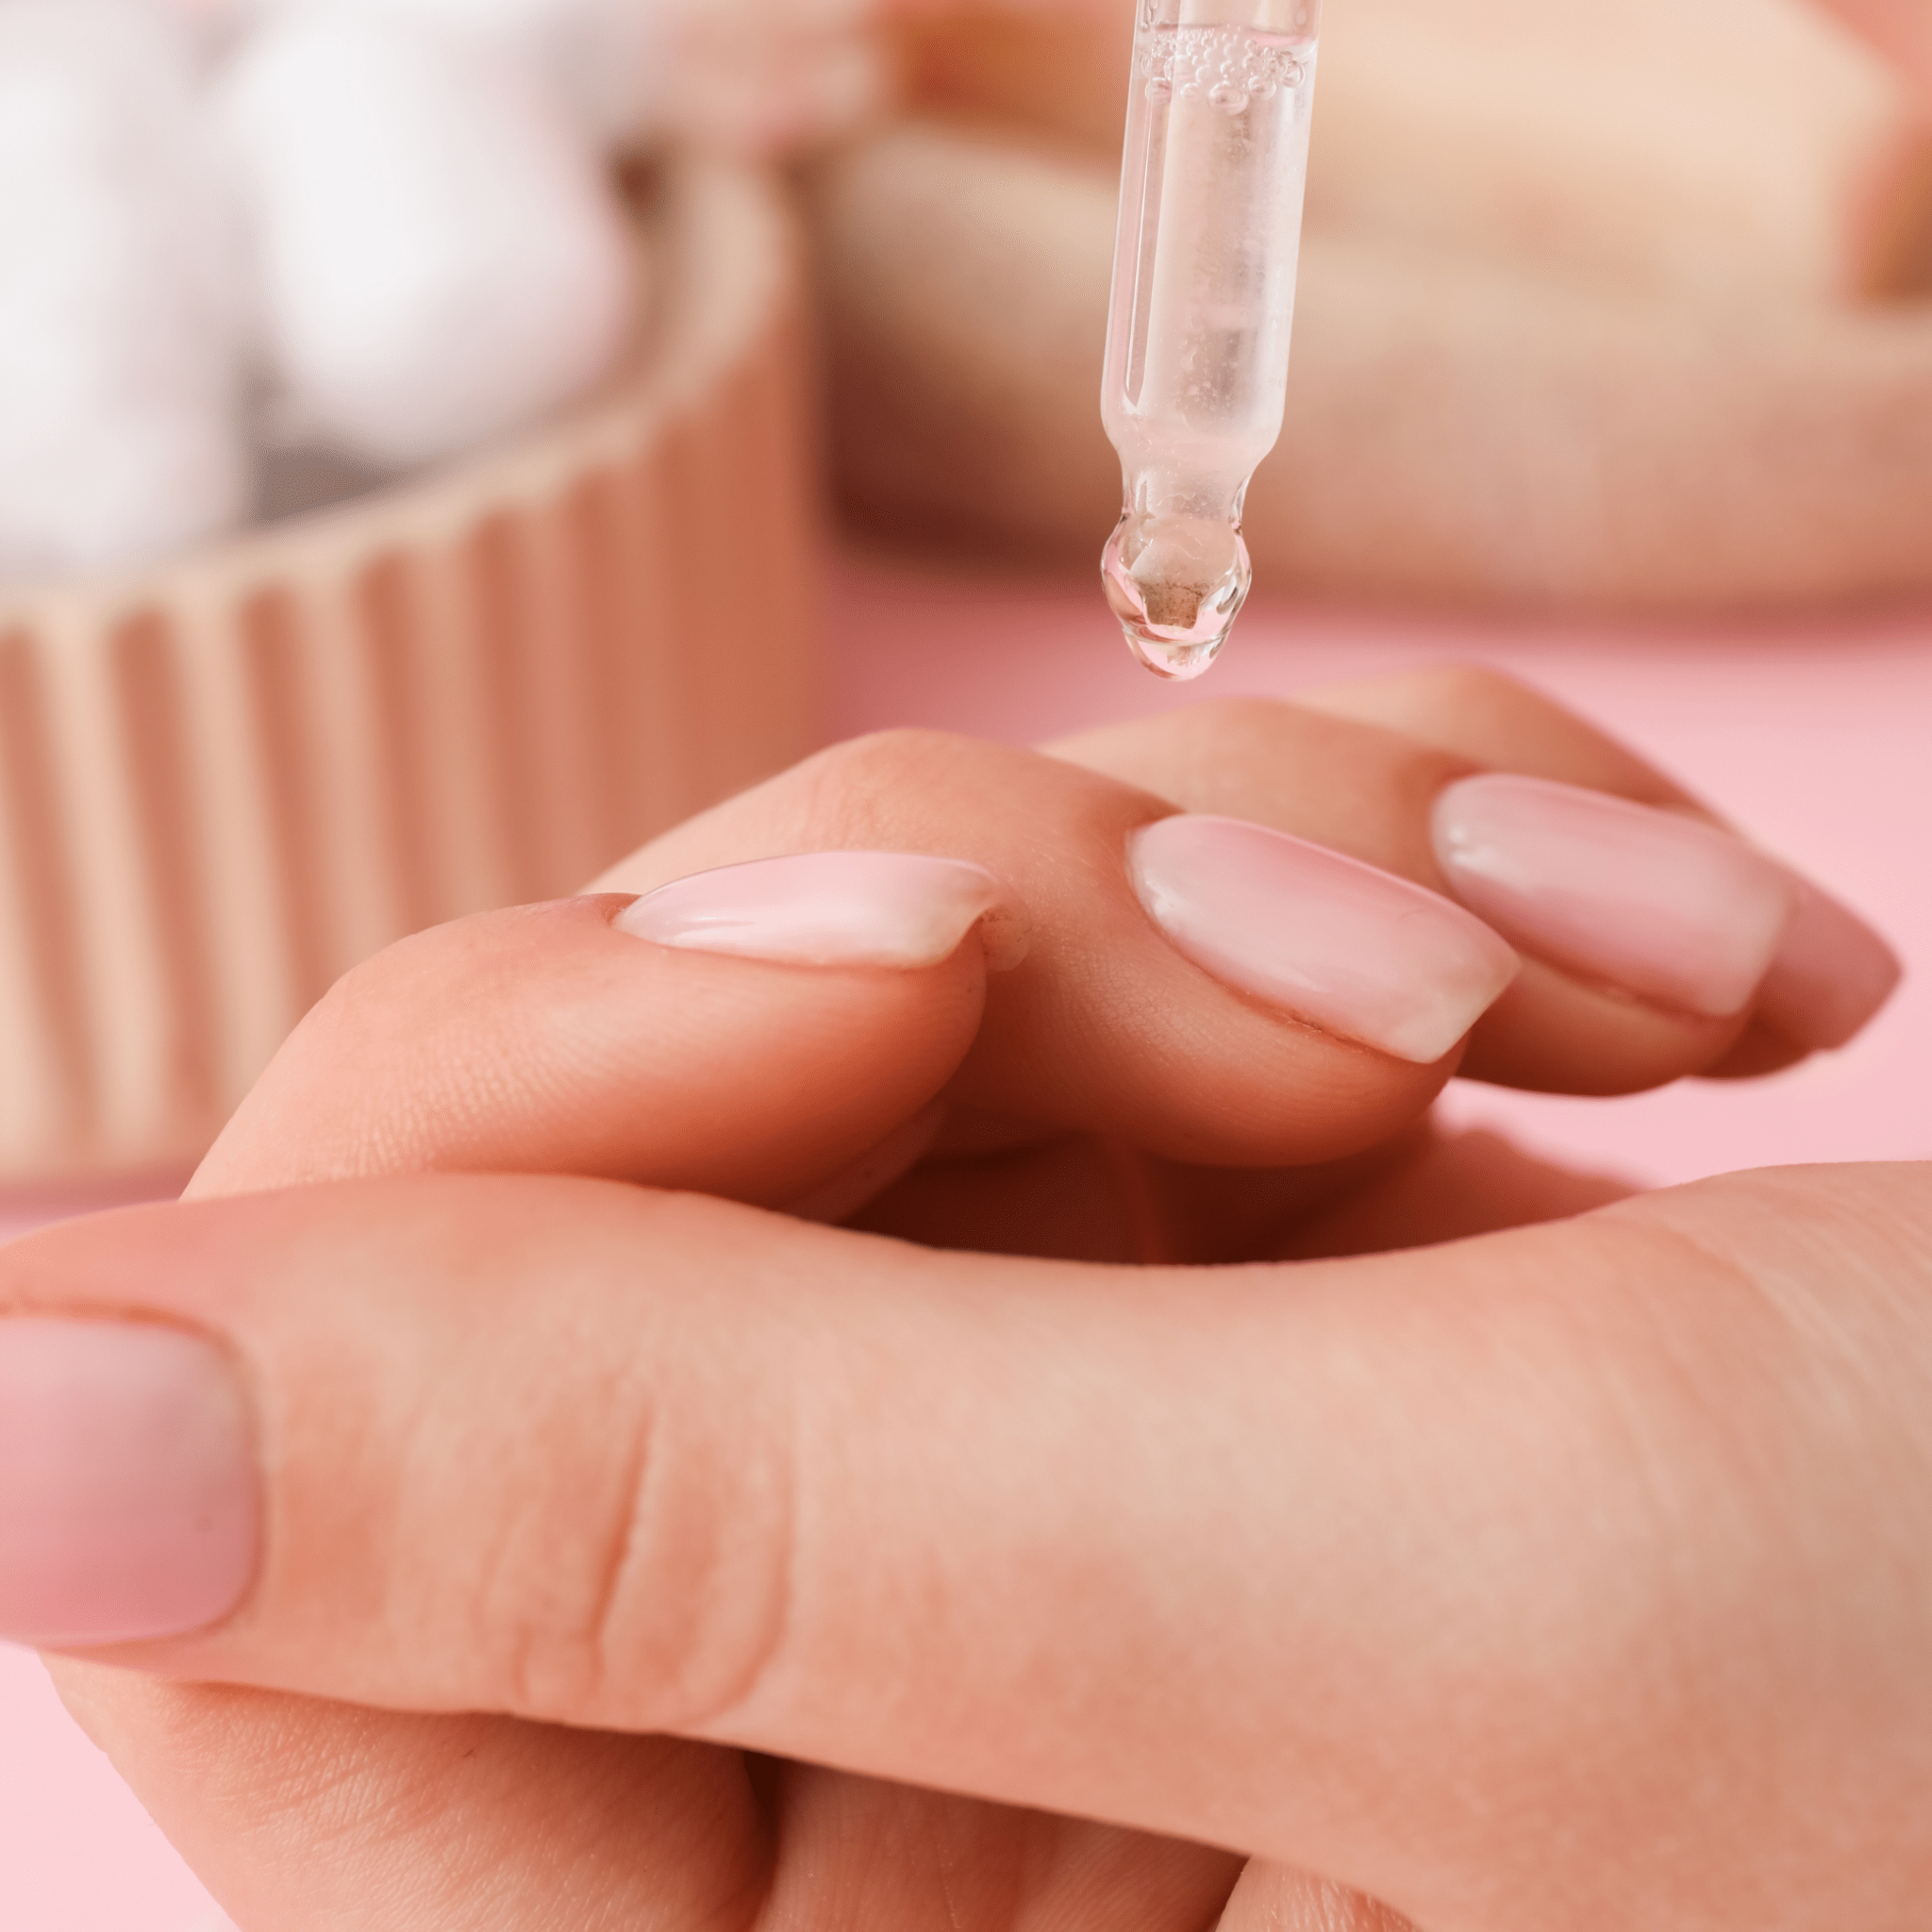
[0, 1316, 260, 1646]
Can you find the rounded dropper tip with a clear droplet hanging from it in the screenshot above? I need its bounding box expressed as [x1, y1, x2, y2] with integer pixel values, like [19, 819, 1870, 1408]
[1099, 510, 1248, 678]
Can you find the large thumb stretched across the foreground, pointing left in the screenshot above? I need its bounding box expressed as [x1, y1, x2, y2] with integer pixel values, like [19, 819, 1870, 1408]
[15, 1169, 1932, 1932]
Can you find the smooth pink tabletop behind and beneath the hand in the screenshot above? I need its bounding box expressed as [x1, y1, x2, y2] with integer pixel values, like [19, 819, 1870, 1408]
[0, 541, 1932, 1932]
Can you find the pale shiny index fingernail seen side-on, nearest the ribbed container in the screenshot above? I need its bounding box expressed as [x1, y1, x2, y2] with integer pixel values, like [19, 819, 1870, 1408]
[612, 852, 1025, 970]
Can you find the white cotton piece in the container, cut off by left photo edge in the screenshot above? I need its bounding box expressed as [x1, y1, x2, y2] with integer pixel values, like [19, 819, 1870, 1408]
[0, 0, 249, 575]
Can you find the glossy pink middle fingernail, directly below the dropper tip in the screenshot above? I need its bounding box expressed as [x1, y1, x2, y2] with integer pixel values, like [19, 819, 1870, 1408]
[1128, 813, 1517, 1066]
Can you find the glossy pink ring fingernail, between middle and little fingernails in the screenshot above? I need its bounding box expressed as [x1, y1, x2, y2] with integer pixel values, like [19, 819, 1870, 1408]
[1432, 773, 1795, 1018]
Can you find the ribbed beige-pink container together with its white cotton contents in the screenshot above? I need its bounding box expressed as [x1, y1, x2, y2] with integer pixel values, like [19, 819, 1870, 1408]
[0, 0, 891, 1189]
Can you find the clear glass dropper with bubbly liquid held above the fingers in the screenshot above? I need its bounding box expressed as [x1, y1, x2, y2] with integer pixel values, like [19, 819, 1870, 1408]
[1101, 0, 1316, 678]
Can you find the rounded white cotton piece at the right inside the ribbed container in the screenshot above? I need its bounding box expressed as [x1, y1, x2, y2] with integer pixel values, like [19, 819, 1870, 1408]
[216, 4, 638, 468]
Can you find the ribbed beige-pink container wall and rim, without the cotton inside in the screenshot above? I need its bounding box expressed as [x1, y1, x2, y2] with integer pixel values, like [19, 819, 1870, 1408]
[0, 162, 817, 1184]
